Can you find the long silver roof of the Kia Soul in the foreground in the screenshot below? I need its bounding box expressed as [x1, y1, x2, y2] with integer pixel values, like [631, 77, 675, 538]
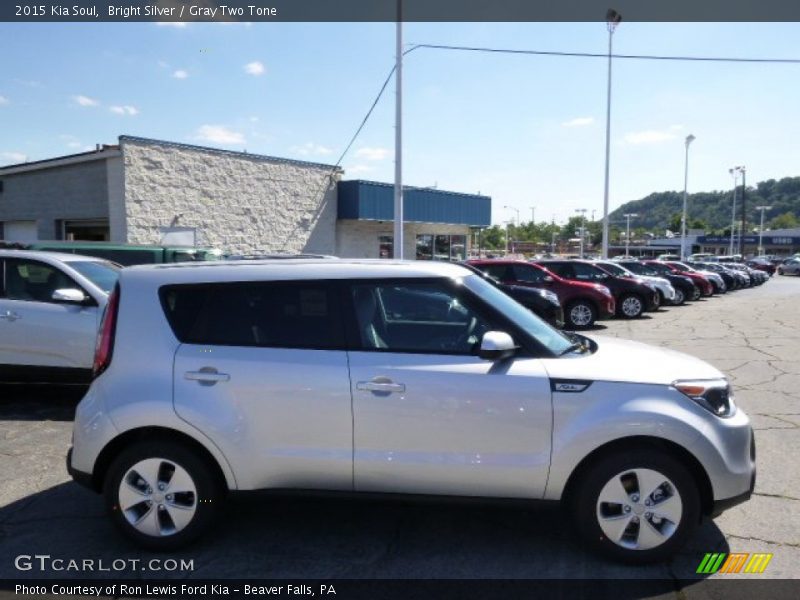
[123, 258, 474, 285]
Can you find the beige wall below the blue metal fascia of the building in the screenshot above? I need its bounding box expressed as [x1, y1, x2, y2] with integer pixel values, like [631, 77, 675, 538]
[336, 219, 470, 260]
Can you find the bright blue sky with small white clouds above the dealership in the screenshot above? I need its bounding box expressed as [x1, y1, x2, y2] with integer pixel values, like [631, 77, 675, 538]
[0, 22, 800, 223]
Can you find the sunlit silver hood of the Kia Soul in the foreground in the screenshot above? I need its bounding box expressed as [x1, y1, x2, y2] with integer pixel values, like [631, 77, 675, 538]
[545, 335, 724, 385]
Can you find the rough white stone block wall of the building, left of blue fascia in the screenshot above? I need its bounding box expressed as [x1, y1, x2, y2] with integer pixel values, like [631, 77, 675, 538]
[120, 136, 340, 254]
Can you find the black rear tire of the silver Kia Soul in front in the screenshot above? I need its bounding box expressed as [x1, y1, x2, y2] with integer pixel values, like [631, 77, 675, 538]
[103, 440, 223, 552]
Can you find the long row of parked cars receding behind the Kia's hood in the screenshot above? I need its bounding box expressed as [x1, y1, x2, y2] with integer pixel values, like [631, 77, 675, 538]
[465, 259, 770, 329]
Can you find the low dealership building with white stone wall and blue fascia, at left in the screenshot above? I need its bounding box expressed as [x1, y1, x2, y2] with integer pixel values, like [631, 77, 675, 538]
[0, 136, 491, 260]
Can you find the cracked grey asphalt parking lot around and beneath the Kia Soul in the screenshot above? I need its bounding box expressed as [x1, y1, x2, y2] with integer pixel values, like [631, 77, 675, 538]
[0, 276, 800, 597]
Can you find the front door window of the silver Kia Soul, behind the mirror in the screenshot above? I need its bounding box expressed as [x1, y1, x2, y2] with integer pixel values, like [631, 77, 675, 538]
[352, 282, 491, 354]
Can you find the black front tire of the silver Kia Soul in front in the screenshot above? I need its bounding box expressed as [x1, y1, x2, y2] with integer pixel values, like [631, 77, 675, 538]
[571, 448, 701, 564]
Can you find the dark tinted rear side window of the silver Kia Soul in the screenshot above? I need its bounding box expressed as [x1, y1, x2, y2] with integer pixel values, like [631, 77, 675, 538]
[161, 282, 344, 350]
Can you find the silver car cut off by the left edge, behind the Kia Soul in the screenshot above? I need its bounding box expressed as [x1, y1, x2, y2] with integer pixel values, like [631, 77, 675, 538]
[0, 250, 119, 384]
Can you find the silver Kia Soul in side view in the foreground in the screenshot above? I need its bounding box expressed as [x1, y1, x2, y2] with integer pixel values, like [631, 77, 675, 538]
[67, 259, 755, 562]
